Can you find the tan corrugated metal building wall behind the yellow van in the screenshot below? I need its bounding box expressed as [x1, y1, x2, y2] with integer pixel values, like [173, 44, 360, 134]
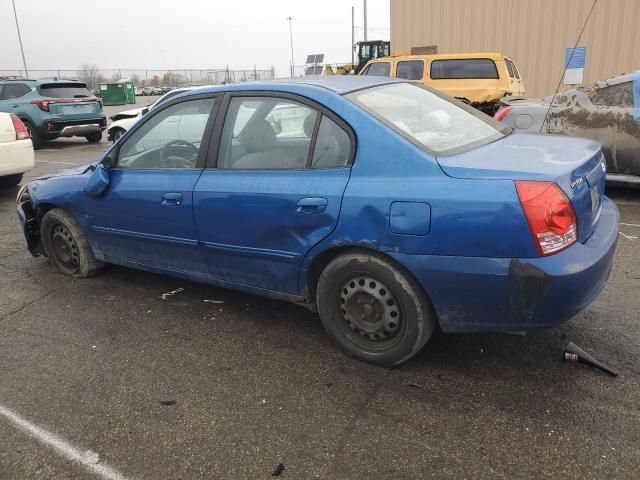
[391, 0, 640, 96]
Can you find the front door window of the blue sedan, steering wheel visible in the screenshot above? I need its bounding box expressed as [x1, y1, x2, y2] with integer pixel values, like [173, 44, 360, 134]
[118, 98, 215, 168]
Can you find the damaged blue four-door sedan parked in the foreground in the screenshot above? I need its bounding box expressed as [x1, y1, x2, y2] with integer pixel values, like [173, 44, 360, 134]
[17, 77, 619, 365]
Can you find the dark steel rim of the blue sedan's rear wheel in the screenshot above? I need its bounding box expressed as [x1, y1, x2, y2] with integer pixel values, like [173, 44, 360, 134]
[339, 275, 403, 346]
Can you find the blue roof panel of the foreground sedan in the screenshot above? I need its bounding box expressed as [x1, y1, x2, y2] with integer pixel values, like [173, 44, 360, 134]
[188, 75, 406, 95]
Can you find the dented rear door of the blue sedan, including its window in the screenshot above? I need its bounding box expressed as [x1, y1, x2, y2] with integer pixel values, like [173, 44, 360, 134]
[194, 92, 355, 294]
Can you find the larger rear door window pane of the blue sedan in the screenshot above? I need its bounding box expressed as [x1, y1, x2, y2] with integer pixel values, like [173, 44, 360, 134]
[218, 97, 318, 170]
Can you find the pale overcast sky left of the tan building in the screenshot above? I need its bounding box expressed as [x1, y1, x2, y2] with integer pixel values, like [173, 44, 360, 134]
[0, 0, 389, 76]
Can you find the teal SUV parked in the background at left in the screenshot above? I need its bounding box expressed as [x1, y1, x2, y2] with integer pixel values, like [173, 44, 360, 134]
[0, 79, 107, 149]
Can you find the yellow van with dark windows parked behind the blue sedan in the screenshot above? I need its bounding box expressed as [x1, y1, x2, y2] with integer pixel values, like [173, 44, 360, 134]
[359, 53, 525, 115]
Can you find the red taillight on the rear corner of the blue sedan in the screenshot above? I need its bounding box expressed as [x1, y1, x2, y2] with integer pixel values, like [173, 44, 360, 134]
[516, 181, 578, 256]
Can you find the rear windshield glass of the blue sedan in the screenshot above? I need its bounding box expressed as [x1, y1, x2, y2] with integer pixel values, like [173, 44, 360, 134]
[347, 83, 511, 155]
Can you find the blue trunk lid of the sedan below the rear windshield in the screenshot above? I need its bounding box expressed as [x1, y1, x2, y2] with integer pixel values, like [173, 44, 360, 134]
[438, 133, 606, 242]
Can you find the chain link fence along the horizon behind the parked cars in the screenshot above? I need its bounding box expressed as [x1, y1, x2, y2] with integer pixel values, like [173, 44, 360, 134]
[0, 66, 275, 89]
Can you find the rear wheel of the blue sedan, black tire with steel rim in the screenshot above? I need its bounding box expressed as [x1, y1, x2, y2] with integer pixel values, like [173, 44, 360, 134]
[316, 252, 436, 367]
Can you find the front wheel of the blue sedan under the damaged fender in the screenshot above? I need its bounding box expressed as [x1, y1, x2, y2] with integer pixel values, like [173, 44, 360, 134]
[40, 208, 104, 278]
